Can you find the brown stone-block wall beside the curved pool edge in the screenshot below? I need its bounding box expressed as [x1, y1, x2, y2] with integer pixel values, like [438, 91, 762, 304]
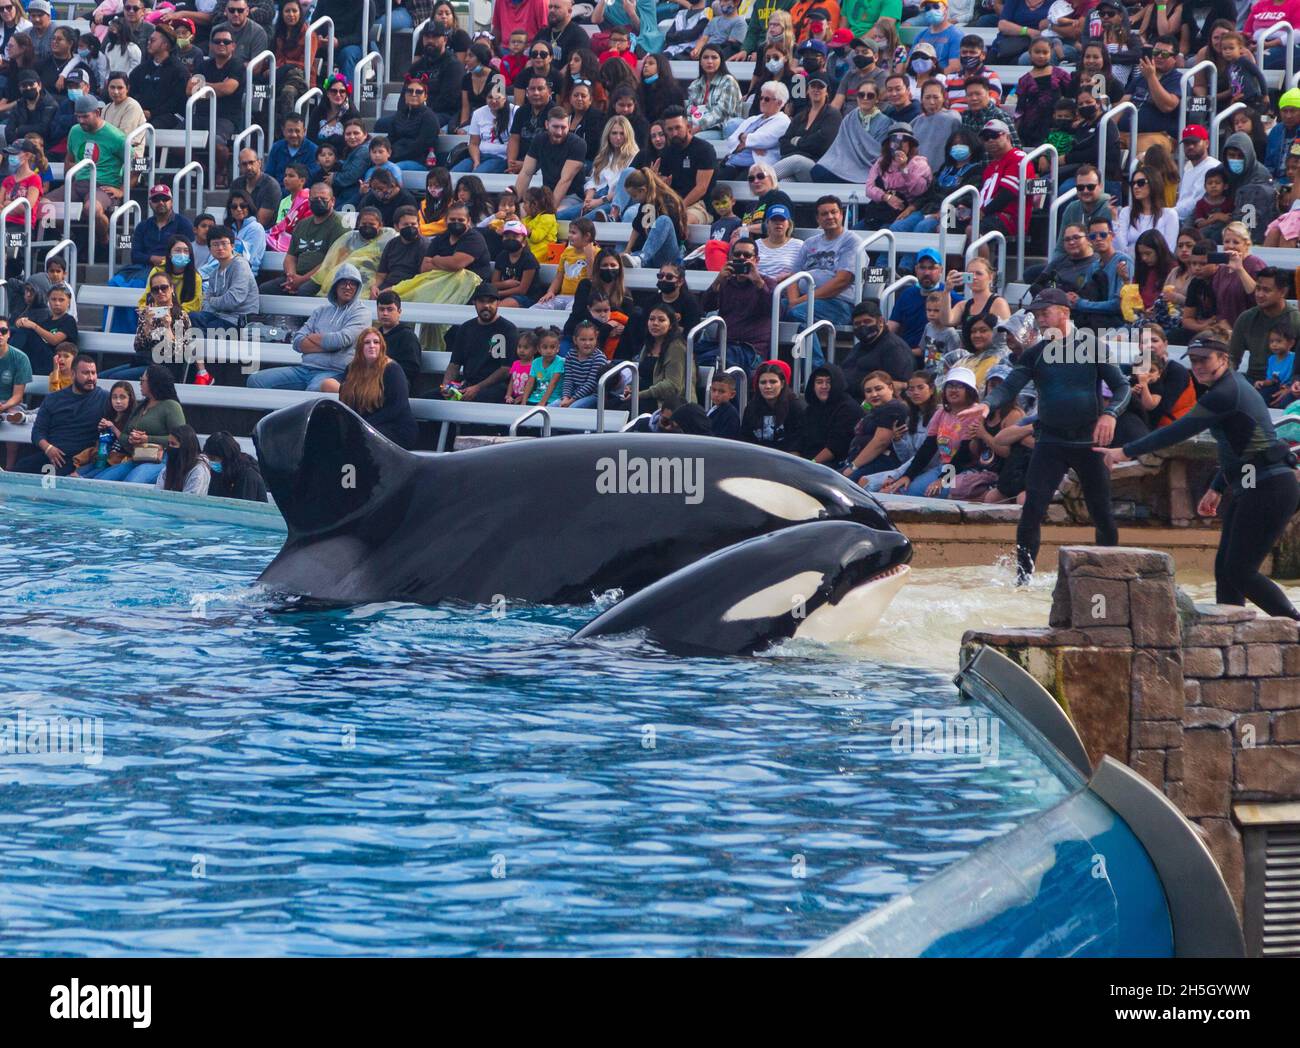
[962, 546, 1300, 910]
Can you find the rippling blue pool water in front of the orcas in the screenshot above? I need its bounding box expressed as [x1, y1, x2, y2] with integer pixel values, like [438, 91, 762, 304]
[0, 488, 1066, 956]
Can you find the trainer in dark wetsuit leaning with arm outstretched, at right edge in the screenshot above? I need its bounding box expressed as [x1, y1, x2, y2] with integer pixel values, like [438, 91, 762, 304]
[1104, 338, 1300, 619]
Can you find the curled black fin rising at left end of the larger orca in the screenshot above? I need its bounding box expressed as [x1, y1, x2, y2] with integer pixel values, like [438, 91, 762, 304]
[252, 398, 416, 538]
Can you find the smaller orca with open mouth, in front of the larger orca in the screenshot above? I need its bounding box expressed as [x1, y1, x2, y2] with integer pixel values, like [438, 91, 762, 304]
[572, 520, 911, 655]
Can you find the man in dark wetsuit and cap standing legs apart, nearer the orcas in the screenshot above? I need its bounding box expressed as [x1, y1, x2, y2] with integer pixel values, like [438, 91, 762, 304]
[963, 287, 1131, 583]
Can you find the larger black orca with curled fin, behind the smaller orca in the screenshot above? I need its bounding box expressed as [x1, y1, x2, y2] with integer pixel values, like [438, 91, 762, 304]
[254, 399, 893, 603]
